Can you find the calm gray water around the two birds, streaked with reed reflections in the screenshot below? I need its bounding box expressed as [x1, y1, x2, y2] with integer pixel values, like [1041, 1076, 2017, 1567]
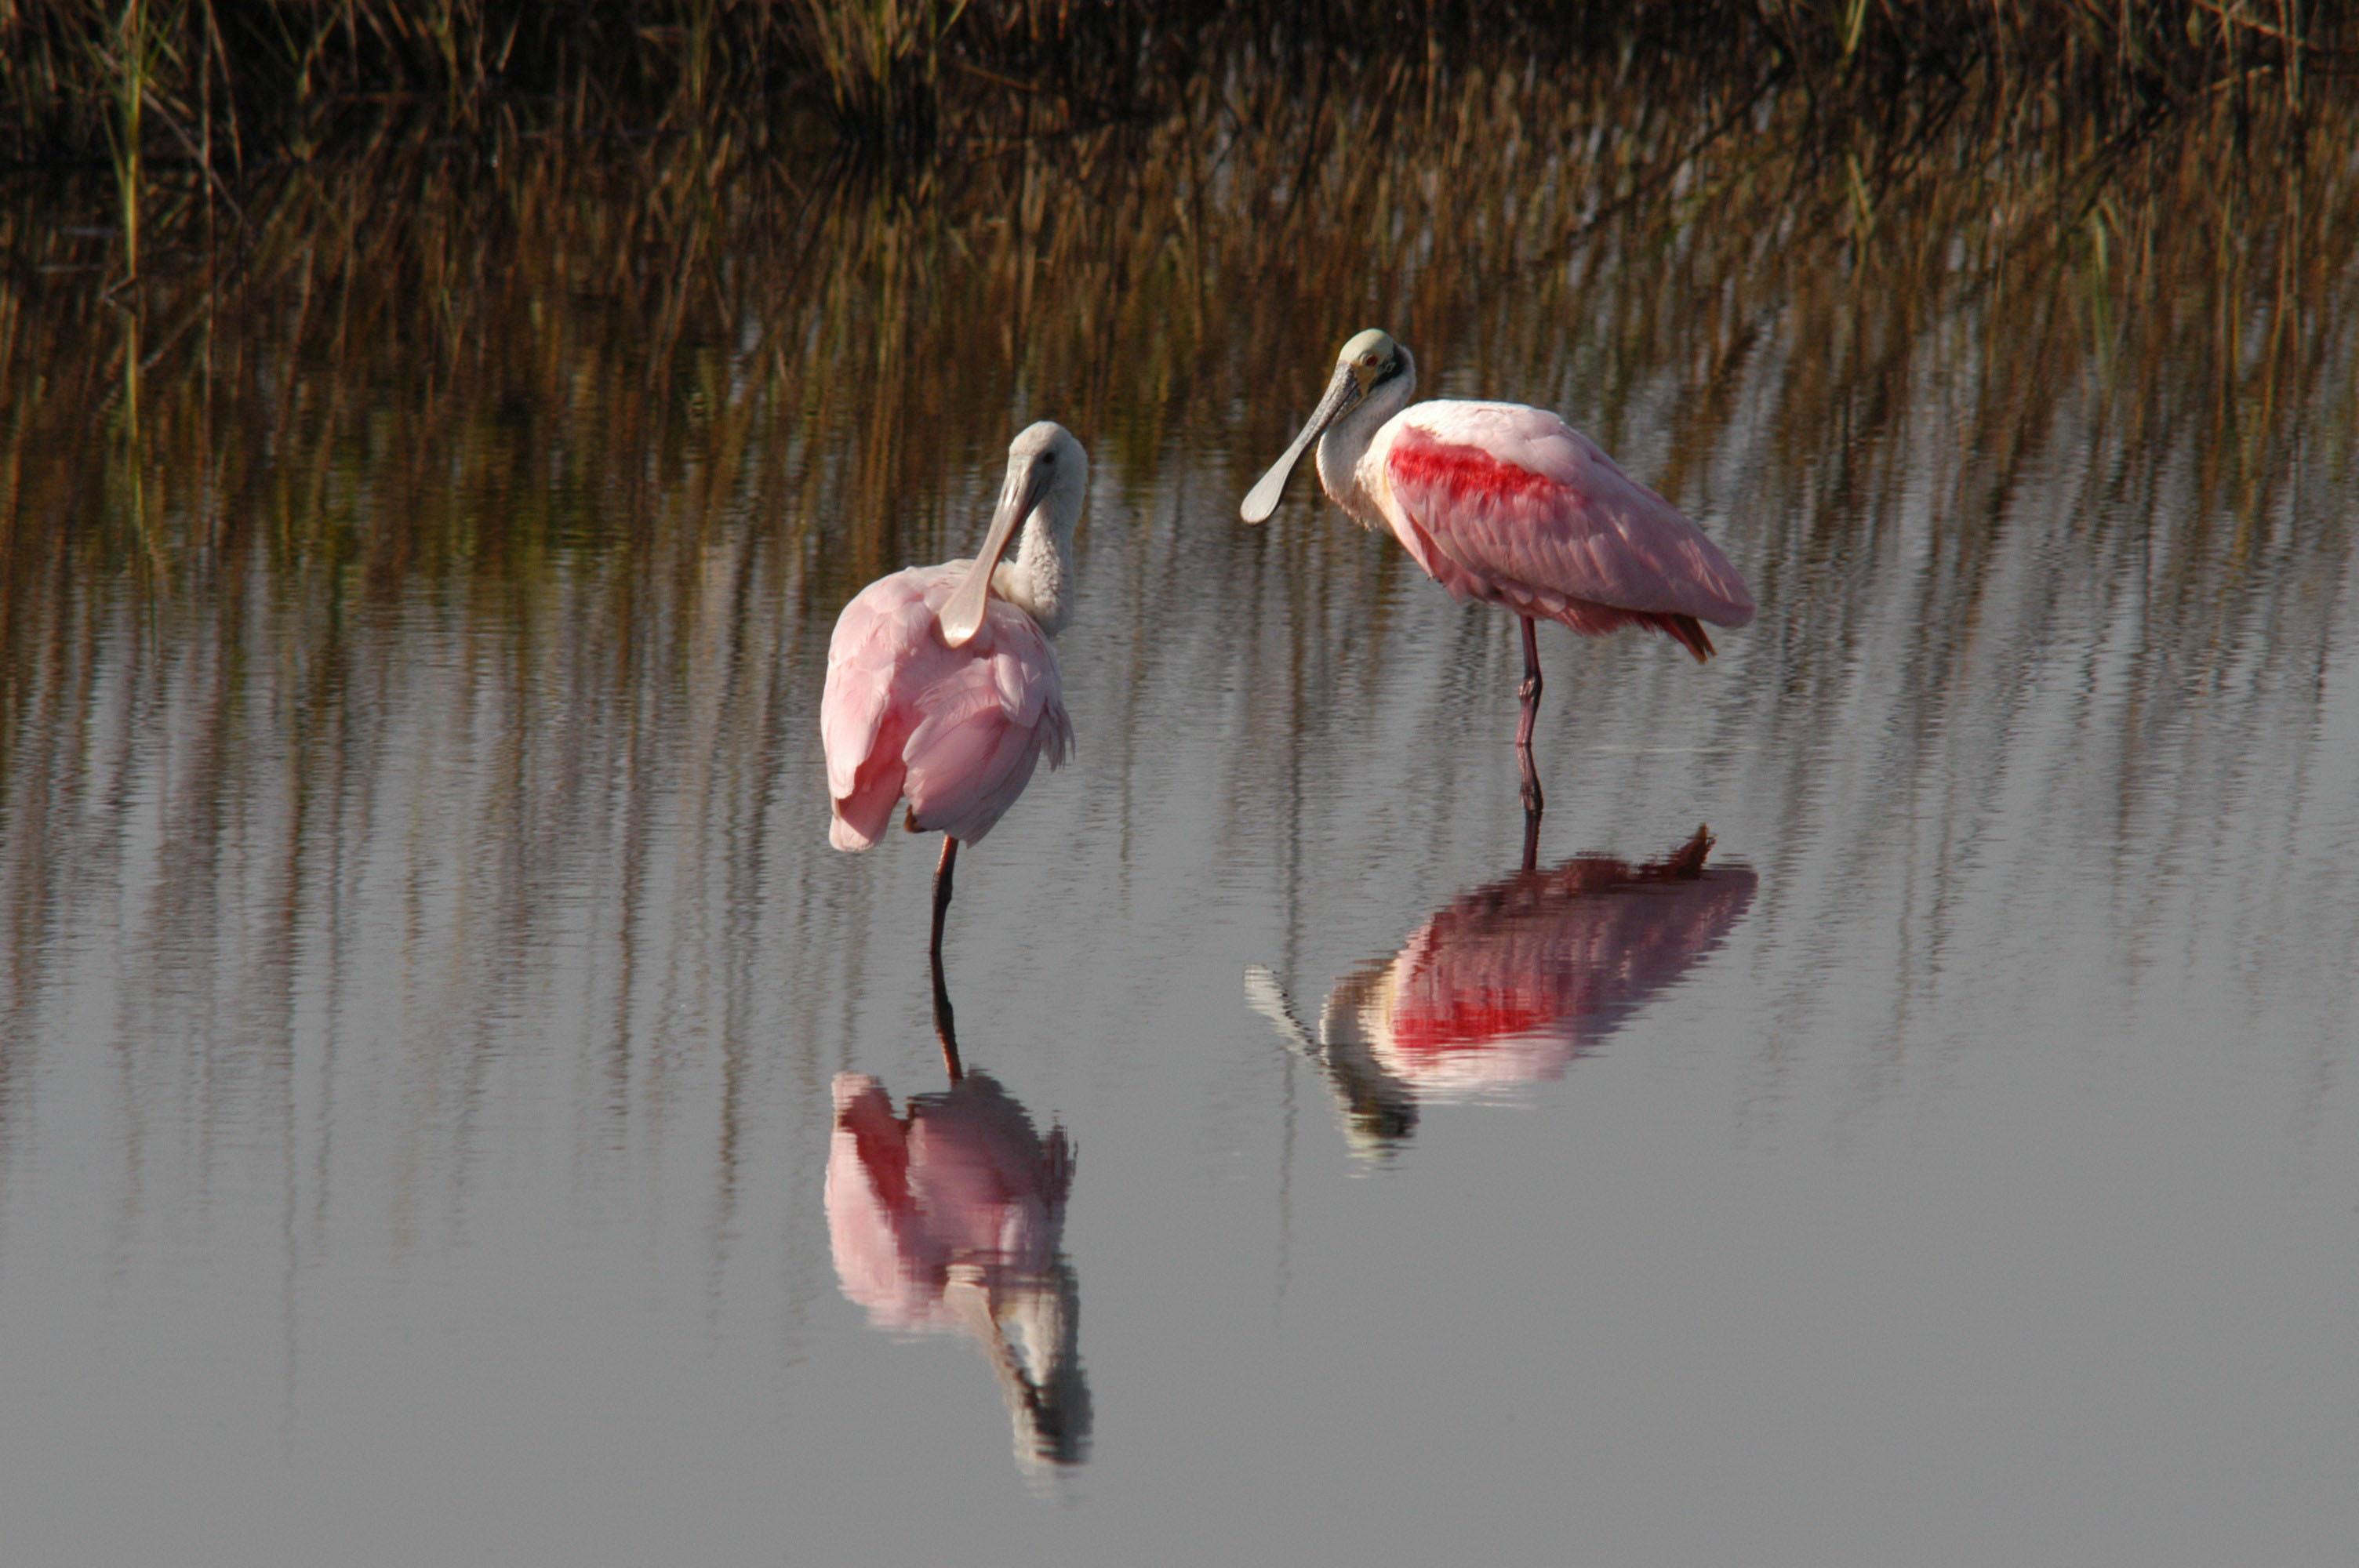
[0, 82, 2359, 1563]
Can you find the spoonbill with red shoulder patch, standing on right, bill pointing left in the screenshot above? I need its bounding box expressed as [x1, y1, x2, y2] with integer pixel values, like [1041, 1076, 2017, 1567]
[1238, 328, 1753, 816]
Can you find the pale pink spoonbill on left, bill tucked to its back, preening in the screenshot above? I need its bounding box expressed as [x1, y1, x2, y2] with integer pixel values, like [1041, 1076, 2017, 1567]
[819, 419, 1090, 964]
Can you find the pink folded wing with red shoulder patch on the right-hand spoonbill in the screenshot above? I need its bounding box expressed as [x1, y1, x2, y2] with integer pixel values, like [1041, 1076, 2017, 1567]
[1371, 401, 1753, 658]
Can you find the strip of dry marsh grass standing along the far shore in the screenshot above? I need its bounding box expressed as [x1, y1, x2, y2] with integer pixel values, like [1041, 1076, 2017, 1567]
[0, 0, 2359, 184]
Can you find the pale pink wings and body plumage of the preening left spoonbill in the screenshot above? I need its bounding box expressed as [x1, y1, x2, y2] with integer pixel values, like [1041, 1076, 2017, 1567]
[819, 564, 1074, 849]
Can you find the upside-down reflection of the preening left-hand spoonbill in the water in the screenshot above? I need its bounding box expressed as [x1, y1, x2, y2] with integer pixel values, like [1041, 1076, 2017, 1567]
[828, 971, 1090, 1469]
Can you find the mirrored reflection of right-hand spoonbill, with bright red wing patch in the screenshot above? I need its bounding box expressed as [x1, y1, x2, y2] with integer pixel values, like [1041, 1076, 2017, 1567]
[1245, 828, 1755, 1158]
